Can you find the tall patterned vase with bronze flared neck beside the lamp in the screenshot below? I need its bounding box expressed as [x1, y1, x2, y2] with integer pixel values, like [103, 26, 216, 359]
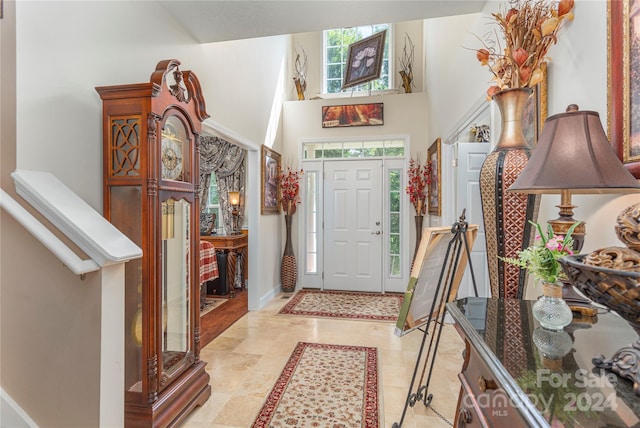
[480, 88, 540, 299]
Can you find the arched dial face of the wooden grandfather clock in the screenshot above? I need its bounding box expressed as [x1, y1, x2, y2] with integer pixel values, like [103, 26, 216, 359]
[160, 116, 189, 181]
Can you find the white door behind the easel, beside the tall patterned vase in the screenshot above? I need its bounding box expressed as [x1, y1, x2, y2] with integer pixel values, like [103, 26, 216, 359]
[456, 143, 491, 298]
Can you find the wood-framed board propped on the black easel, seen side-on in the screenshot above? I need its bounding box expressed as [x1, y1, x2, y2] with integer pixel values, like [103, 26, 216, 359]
[394, 224, 478, 336]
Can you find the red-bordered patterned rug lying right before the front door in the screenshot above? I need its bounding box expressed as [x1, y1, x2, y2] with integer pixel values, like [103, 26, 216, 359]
[278, 290, 404, 322]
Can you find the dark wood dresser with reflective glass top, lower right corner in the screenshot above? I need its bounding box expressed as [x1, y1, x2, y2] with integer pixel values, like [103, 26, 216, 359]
[447, 297, 640, 428]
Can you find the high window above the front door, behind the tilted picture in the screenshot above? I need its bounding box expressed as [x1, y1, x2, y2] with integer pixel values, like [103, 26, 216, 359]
[322, 24, 393, 94]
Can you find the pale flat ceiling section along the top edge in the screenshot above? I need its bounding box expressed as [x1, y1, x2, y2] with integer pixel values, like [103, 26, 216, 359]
[160, 0, 486, 43]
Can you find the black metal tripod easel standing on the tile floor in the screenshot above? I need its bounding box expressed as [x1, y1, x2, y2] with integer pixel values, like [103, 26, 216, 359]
[393, 209, 478, 428]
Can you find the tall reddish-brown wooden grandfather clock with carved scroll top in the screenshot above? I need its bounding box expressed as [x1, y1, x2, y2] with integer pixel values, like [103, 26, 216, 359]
[96, 60, 211, 427]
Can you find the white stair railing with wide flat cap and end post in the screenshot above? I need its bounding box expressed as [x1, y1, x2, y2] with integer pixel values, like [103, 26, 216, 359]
[0, 170, 142, 427]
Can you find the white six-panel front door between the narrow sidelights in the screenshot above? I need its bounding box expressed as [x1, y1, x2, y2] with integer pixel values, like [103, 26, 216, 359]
[324, 160, 384, 292]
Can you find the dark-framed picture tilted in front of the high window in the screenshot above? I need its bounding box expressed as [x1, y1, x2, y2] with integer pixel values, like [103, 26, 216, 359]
[341, 30, 387, 89]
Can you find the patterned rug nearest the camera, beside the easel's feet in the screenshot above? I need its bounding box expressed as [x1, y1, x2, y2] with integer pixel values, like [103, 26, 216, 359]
[252, 342, 379, 428]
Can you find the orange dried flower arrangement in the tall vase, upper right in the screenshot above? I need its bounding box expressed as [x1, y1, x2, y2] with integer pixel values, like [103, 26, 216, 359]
[476, 0, 574, 97]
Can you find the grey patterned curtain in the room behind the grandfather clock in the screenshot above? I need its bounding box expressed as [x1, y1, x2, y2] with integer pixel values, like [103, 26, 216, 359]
[200, 136, 247, 231]
